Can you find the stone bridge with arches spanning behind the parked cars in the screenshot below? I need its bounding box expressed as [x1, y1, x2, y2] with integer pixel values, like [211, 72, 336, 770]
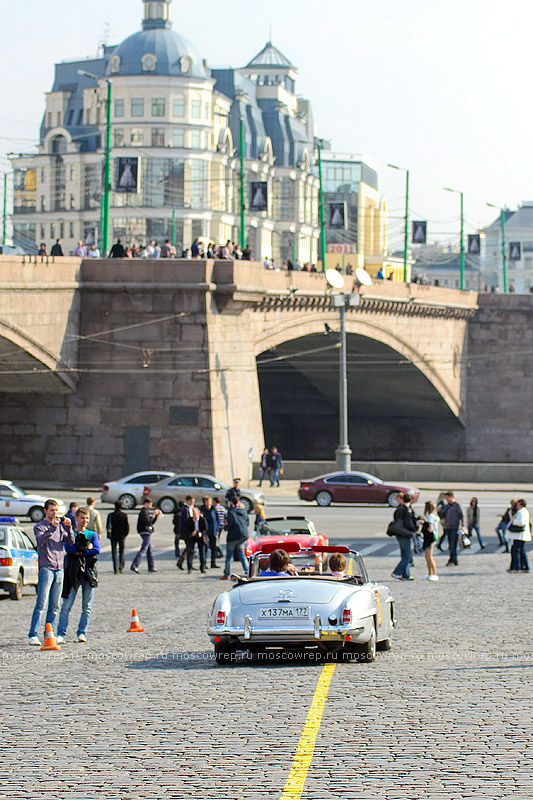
[0, 257, 533, 482]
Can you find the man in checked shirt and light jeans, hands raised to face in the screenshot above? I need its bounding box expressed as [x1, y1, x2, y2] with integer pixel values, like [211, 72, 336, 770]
[29, 500, 74, 646]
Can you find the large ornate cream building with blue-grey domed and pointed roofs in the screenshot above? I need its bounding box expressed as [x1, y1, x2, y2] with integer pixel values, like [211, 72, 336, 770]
[13, 0, 319, 263]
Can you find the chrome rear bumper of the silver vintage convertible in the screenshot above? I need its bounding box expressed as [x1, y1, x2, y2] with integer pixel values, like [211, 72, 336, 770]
[207, 617, 370, 647]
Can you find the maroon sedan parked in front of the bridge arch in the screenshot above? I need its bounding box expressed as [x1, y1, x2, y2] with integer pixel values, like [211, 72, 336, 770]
[298, 472, 419, 506]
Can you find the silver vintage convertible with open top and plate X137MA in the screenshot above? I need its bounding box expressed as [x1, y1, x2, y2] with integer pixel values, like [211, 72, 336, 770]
[207, 542, 395, 664]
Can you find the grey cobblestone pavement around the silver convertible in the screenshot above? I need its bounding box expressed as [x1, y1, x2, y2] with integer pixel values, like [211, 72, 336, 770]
[0, 511, 533, 800]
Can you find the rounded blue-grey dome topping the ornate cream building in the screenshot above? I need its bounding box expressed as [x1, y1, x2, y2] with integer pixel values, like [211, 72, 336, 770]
[107, 28, 208, 78]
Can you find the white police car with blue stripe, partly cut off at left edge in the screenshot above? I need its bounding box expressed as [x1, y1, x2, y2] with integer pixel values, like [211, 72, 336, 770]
[0, 517, 39, 600]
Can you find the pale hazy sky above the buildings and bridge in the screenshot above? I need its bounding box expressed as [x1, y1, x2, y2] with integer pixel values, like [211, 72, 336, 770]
[0, 0, 533, 247]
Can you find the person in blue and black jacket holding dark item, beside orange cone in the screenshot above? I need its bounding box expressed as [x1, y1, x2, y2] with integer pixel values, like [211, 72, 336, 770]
[57, 508, 100, 644]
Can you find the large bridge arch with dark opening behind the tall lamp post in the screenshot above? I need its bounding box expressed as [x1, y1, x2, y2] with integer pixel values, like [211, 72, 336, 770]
[255, 310, 464, 460]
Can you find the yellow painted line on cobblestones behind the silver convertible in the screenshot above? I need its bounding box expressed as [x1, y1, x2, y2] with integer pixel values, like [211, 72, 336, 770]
[280, 664, 336, 800]
